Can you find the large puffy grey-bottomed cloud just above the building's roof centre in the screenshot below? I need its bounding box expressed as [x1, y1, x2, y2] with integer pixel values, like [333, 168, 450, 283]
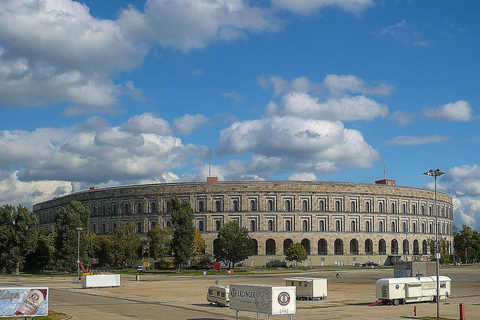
[219, 116, 380, 173]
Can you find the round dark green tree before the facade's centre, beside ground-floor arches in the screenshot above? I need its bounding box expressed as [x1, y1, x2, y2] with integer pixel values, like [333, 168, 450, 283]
[213, 221, 255, 267]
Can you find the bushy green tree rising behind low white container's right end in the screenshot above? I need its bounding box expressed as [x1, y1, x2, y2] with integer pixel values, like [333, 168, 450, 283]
[112, 222, 142, 267]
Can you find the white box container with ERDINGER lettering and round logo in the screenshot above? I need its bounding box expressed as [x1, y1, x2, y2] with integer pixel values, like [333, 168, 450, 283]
[230, 284, 297, 318]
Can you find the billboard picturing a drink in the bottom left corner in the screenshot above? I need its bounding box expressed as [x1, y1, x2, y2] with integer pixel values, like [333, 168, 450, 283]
[0, 287, 49, 318]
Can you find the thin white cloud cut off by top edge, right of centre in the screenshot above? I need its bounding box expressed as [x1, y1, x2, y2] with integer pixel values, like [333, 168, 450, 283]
[272, 0, 375, 14]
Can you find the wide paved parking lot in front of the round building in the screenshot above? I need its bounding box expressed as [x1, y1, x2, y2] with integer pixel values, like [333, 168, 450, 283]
[0, 266, 480, 320]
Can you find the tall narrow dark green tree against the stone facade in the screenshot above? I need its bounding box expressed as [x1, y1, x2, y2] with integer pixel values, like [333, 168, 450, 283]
[169, 196, 195, 272]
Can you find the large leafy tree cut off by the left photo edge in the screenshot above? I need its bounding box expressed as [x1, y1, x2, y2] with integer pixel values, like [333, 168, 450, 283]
[0, 204, 38, 273]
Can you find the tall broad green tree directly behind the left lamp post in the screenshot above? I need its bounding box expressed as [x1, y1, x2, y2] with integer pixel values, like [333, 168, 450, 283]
[54, 201, 92, 272]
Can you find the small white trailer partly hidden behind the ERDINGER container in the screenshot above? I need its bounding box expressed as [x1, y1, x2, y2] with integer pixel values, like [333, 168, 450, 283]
[283, 277, 327, 300]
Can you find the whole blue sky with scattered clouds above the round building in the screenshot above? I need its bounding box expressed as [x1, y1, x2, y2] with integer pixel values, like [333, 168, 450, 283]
[0, 0, 480, 231]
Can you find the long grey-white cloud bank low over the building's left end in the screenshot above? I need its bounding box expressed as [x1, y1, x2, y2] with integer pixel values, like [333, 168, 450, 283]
[0, 114, 208, 203]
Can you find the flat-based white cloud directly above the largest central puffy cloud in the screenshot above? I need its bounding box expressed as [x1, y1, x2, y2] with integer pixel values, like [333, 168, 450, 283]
[266, 92, 388, 121]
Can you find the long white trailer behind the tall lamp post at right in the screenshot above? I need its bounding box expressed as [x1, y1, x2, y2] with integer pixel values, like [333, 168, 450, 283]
[376, 276, 452, 306]
